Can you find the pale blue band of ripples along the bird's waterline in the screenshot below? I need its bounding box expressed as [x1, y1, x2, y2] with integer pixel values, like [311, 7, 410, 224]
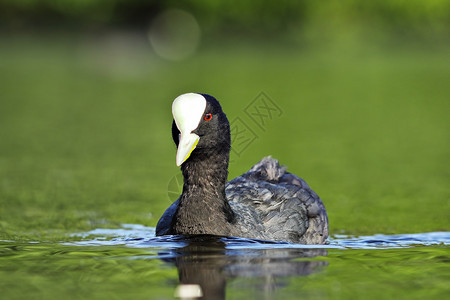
[69, 224, 450, 250]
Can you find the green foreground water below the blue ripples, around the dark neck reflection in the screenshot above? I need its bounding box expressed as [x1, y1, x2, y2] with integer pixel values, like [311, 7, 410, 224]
[0, 237, 450, 299]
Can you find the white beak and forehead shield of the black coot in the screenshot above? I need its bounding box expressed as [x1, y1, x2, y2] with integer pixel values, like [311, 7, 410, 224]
[172, 93, 206, 166]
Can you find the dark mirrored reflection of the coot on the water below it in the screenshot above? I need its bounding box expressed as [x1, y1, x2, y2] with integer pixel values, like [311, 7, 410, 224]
[163, 235, 328, 299]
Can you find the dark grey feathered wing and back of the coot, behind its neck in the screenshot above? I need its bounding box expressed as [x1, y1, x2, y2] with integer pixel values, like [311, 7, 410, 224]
[226, 157, 328, 244]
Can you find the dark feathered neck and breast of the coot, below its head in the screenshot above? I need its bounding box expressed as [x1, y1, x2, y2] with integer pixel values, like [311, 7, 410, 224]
[172, 148, 234, 235]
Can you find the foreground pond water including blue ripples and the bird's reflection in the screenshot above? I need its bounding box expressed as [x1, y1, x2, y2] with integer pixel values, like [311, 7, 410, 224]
[0, 224, 450, 299]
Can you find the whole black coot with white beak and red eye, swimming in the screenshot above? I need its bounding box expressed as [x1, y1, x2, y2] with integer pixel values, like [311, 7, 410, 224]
[156, 93, 328, 244]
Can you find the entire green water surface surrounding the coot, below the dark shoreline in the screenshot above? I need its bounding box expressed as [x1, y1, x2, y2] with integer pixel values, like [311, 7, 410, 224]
[0, 35, 450, 299]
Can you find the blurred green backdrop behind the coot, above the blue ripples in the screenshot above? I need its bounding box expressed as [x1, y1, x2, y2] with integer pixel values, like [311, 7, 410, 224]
[0, 0, 450, 240]
